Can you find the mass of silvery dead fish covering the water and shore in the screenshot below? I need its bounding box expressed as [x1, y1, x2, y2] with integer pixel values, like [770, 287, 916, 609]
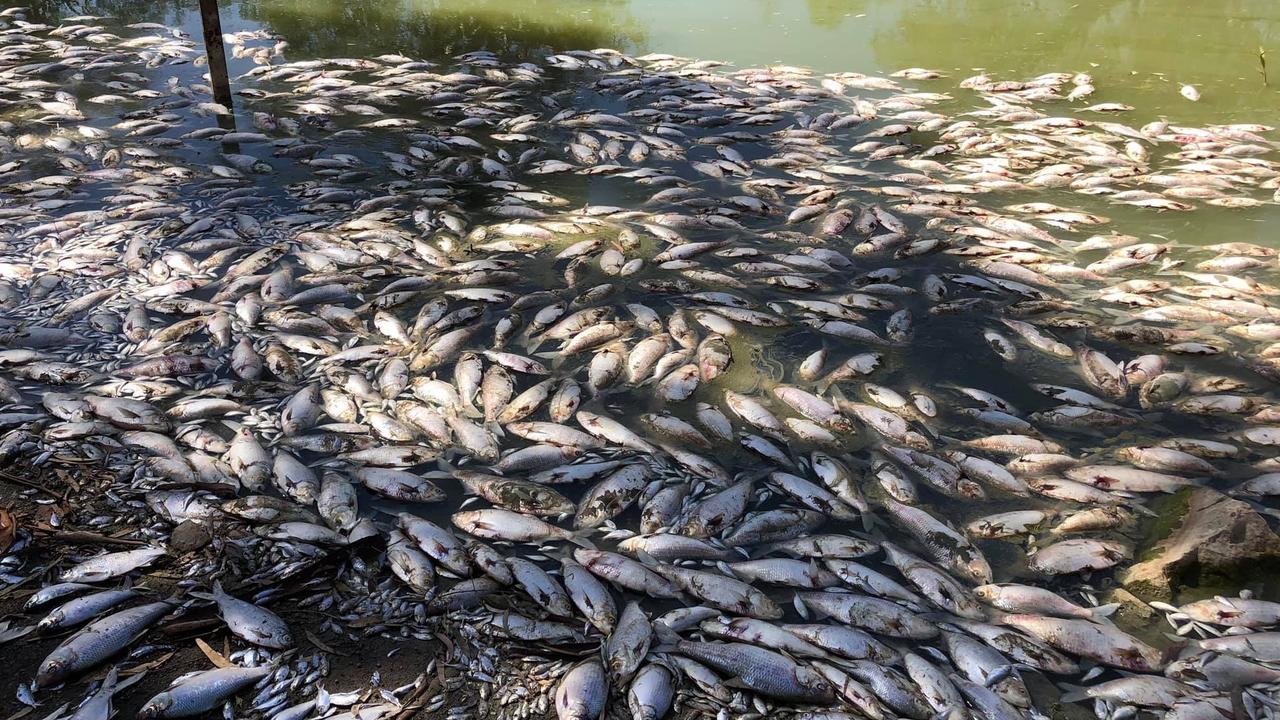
[0, 5, 1280, 720]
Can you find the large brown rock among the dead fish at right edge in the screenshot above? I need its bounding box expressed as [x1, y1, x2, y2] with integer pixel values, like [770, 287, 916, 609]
[1120, 488, 1280, 601]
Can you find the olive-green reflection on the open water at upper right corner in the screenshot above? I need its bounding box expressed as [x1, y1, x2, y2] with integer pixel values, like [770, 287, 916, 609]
[872, 0, 1280, 122]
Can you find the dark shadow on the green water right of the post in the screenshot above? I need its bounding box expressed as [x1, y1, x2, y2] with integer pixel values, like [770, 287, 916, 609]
[232, 0, 646, 58]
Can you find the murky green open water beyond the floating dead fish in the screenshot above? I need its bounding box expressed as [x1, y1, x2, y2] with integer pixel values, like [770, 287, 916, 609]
[27, 0, 1280, 245]
